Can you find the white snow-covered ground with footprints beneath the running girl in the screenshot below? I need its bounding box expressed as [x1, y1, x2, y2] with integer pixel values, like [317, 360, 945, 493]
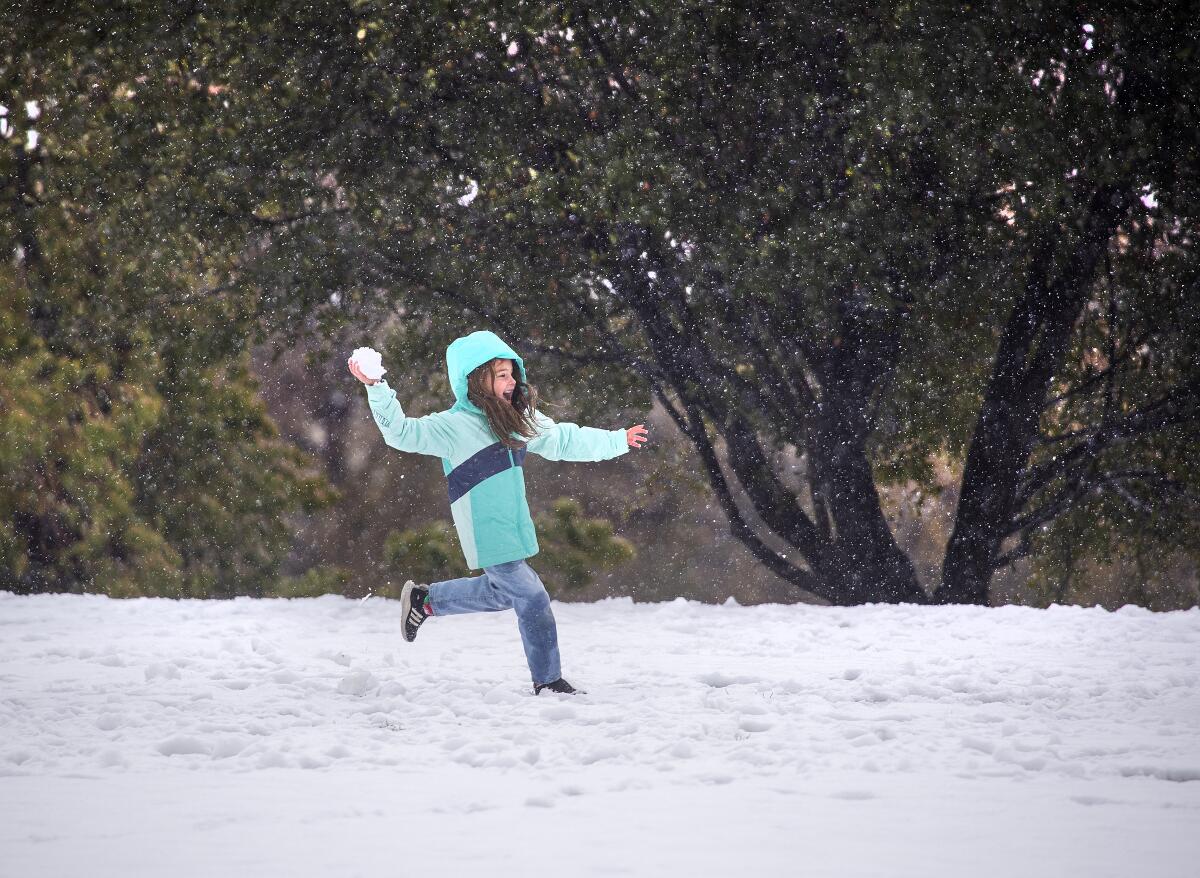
[0, 594, 1200, 878]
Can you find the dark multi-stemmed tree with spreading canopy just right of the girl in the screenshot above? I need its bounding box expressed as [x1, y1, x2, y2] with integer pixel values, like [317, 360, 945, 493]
[234, 1, 964, 602]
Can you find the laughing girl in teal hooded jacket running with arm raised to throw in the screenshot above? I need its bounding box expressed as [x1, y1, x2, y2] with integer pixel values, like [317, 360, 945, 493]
[347, 332, 646, 694]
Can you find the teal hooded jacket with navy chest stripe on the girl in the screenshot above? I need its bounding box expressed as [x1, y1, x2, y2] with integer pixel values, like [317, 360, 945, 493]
[367, 332, 629, 570]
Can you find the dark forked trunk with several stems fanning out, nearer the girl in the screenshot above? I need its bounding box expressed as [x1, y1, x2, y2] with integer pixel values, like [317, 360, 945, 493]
[616, 229, 926, 606]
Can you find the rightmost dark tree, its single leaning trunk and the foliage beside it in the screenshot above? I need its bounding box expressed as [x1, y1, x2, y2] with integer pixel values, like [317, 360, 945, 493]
[940, 4, 1200, 602]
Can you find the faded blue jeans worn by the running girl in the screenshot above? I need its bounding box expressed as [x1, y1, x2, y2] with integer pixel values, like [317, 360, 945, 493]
[430, 560, 563, 684]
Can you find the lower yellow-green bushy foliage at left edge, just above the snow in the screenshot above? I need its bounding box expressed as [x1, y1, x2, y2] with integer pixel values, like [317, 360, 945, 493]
[0, 259, 332, 596]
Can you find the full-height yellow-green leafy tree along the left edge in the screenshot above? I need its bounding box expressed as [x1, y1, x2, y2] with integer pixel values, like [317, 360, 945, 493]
[0, 6, 330, 596]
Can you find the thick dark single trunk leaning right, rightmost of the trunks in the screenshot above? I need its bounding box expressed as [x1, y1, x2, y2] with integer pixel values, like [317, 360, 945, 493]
[934, 187, 1132, 603]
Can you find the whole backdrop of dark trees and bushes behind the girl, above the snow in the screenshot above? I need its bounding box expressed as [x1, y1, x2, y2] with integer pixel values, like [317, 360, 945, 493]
[0, 0, 1200, 609]
